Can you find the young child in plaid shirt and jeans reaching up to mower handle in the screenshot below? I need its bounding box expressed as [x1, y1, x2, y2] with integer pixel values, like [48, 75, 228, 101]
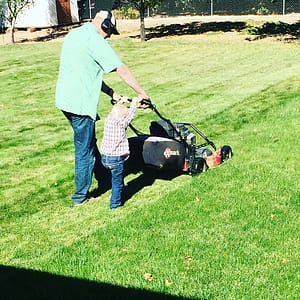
[100, 98, 138, 209]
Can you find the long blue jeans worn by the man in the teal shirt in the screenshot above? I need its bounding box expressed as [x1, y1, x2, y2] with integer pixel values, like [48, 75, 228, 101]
[63, 112, 97, 204]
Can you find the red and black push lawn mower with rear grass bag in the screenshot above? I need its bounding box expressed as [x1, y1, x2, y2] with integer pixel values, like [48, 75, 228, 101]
[115, 99, 233, 175]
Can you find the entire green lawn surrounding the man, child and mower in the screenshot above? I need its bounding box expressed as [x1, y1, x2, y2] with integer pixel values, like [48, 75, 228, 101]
[0, 36, 300, 299]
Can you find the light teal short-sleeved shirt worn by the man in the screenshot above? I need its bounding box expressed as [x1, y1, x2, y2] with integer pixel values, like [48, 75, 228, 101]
[56, 23, 122, 120]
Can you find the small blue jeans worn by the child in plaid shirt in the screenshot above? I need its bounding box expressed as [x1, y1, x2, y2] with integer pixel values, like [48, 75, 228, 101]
[101, 154, 126, 209]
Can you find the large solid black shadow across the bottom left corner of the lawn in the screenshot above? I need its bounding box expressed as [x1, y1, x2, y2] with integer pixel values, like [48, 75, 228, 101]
[0, 266, 193, 300]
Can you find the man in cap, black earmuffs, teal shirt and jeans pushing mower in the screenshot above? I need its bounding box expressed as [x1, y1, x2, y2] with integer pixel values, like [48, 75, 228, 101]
[56, 10, 149, 206]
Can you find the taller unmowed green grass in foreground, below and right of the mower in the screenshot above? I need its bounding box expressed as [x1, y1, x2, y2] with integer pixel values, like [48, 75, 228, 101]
[34, 85, 299, 299]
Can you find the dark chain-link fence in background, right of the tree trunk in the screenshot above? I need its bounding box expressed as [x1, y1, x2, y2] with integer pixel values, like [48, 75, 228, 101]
[156, 0, 300, 16]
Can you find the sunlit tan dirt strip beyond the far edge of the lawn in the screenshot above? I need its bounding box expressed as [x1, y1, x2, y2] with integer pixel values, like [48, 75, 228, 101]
[0, 13, 300, 45]
